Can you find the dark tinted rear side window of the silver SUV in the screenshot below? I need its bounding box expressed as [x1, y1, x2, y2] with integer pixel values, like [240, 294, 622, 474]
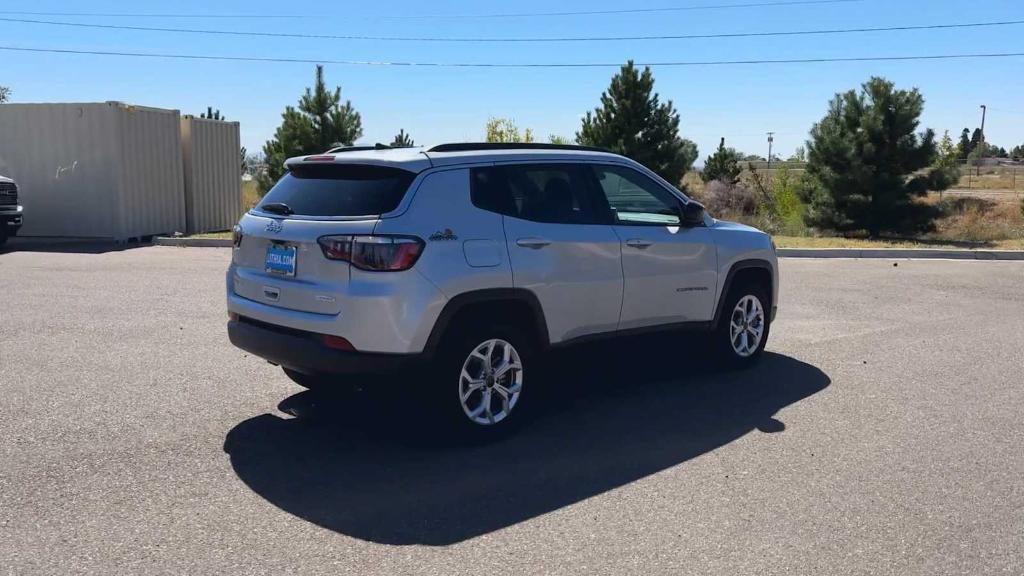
[472, 164, 607, 224]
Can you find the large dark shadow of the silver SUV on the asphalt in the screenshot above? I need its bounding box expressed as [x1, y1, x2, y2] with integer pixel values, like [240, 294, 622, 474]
[224, 338, 830, 545]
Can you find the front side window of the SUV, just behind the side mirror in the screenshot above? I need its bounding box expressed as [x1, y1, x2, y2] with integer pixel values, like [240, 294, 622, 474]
[593, 165, 681, 225]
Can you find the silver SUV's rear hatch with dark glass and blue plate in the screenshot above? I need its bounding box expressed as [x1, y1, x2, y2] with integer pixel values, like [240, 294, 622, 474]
[233, 163, 416, 315]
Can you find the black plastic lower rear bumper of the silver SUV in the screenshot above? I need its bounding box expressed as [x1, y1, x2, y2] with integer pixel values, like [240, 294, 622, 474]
[227, 319, 421, 375]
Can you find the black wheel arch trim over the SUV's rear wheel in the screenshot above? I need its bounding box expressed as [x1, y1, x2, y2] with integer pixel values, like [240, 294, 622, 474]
[423, 288, 551, 357]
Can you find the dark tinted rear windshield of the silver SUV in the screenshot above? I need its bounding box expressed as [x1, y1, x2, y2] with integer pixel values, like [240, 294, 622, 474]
[257, 164, 416, 216]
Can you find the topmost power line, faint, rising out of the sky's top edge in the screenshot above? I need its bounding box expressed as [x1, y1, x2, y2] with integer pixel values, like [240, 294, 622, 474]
[0, 0, 864, 19]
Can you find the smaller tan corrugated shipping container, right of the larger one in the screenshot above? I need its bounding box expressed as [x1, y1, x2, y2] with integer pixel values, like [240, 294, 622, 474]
[181, 116, 242, 234]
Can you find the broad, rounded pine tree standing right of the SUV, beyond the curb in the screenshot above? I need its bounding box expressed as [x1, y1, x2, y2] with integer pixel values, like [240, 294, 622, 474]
[802, 78, 954, 237]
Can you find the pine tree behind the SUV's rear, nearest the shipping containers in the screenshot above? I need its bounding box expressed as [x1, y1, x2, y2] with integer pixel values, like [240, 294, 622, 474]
[259, 66, 362, 191]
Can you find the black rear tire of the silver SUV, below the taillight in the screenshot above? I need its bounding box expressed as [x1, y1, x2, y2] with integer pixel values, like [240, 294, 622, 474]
[423, 325, 541, 439]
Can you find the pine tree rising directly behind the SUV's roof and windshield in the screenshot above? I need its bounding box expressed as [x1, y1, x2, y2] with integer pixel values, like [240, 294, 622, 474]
[577, 60, 697, 186]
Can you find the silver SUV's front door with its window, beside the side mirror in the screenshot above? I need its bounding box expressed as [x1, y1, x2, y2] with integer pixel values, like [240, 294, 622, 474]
[592, 164, 718, 330]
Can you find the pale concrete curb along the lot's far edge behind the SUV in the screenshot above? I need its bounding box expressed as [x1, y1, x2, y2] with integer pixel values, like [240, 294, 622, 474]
[153, 237, 1024, 260]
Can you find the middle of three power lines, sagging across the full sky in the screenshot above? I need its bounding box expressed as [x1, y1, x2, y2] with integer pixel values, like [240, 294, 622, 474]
[0, 16, 1024, 43]
